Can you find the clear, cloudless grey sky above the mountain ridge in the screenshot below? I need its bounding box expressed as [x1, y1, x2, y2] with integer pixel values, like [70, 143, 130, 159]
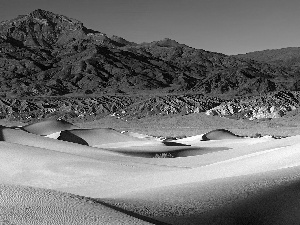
[0, 0, 300, 55]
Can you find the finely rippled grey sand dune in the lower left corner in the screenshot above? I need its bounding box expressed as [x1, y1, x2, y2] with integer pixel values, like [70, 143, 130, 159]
[0, 185, 155, 225]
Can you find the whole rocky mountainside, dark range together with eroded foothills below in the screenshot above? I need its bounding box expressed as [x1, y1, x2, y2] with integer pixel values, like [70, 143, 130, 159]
[0, 9, 300, 121]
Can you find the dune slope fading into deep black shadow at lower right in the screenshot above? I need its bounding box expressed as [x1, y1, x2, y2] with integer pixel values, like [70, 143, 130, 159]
[104, 167, 300, 225]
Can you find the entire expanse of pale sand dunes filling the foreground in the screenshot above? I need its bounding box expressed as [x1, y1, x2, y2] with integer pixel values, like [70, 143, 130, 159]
[0, 120, 300, 224]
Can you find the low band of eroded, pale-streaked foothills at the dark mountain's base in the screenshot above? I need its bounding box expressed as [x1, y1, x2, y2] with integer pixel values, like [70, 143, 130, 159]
[0, 91, 300, 122]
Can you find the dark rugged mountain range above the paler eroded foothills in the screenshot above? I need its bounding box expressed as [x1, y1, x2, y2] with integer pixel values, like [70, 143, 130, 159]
[0, 9, 300, 97]
